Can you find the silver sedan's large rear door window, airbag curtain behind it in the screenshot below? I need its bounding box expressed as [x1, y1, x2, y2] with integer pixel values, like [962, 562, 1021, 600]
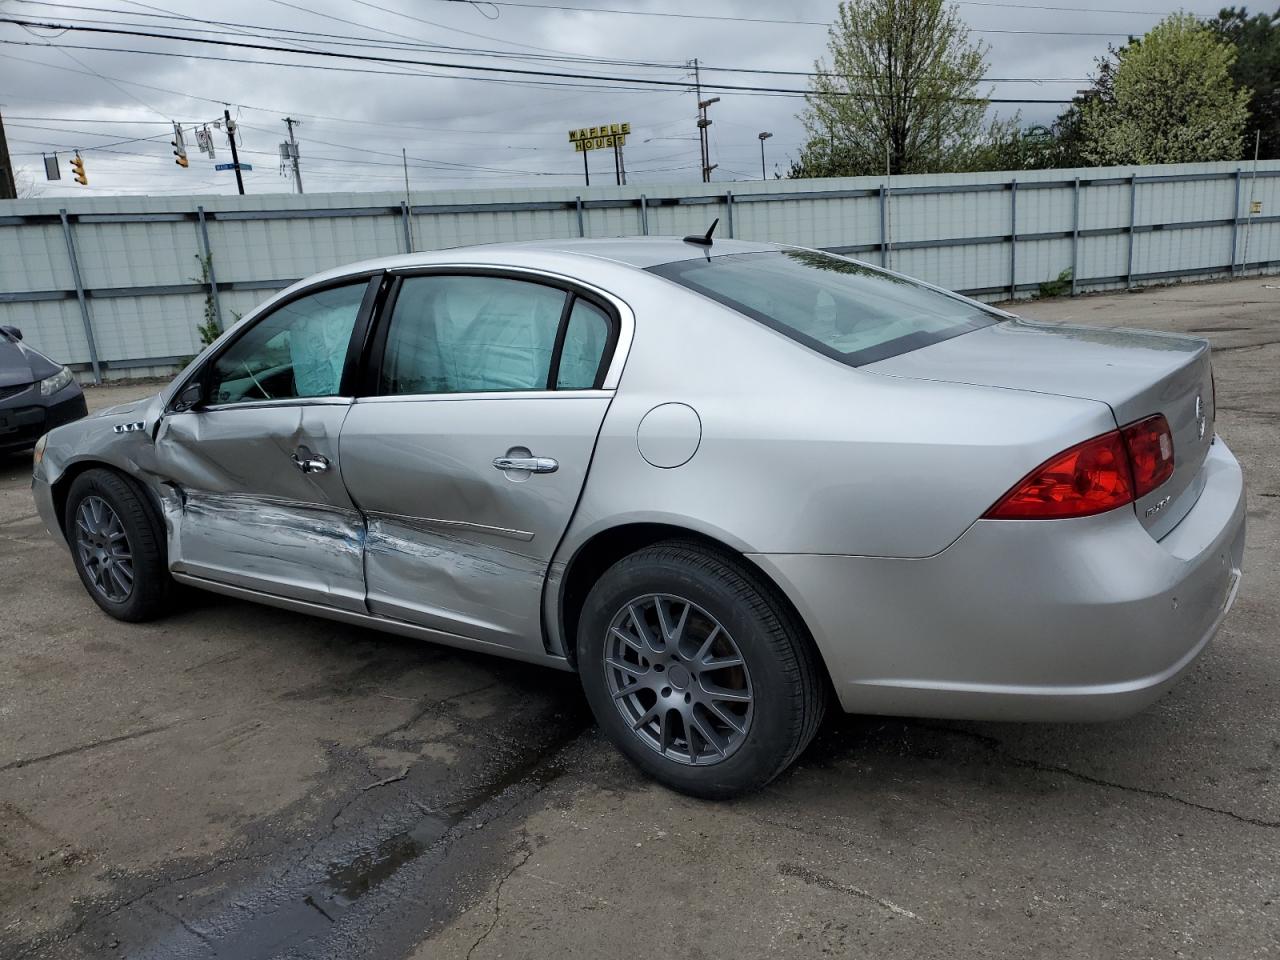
[379, 276, 567, 394]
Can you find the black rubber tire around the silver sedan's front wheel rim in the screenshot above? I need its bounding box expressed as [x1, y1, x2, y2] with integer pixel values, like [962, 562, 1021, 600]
[63, 468, 175, 623]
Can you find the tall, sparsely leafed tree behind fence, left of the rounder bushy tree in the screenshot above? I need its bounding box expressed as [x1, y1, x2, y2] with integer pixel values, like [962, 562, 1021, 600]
[791, 0, 988, 177]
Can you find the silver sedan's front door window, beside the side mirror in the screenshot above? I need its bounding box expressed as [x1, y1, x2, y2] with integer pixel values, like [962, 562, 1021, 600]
[209, 280, 369, 403]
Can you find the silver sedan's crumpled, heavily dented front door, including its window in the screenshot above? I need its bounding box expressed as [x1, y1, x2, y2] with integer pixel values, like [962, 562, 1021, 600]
[156, 276, 376, 612]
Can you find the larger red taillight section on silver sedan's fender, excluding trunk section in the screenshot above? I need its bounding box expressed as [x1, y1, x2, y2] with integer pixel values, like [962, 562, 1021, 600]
[983, 430, 1133, 520]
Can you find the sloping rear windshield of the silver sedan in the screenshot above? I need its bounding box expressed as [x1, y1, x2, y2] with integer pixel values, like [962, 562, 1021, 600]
[649, 250, 1004, 366]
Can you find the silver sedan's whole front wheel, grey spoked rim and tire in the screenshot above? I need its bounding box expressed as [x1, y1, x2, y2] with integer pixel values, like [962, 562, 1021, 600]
[64, 470, 173, 622]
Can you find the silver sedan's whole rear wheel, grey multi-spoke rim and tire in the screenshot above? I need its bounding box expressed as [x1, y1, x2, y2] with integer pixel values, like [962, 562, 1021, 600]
[577, 541, 827, 799]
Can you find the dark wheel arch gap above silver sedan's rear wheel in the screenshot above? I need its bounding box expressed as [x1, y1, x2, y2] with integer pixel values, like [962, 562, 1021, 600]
[557, 522, 832, 685]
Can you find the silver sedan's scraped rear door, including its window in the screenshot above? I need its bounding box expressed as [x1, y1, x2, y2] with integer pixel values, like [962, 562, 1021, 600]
[342, 275, 616, 653]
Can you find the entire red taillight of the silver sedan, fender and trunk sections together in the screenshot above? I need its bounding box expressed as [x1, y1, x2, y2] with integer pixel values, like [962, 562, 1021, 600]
[983, 413, 1174, 520]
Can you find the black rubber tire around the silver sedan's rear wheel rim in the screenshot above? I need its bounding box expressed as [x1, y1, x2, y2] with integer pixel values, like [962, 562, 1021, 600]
[577, 540, 827, 800]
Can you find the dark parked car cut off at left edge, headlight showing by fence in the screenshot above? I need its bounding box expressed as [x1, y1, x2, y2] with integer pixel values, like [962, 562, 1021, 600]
[0, 326, 87, 454]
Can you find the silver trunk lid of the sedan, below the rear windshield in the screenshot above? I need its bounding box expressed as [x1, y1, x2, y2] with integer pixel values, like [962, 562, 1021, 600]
[861, 320, 1215, 539]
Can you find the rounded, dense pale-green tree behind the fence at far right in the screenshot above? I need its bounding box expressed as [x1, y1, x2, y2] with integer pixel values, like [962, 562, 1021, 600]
[1080, 13, 1251, 164]
